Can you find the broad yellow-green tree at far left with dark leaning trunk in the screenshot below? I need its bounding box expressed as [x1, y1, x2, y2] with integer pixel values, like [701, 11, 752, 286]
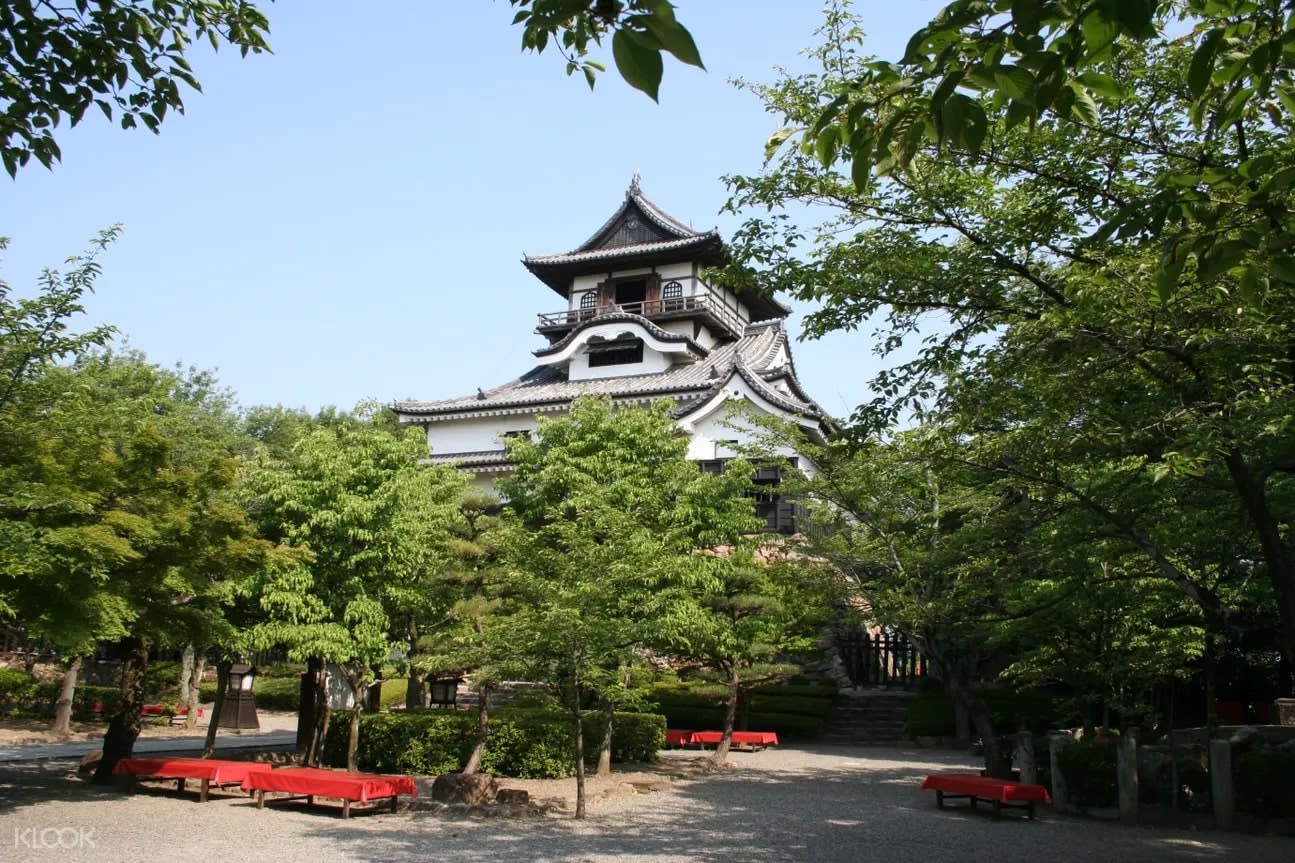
[0, 350, 268, 767]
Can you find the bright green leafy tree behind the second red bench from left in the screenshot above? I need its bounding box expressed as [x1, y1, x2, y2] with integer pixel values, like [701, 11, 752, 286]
[249, 408, 466, 771]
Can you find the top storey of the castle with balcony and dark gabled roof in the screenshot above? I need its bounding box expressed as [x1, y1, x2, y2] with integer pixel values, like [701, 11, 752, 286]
[522, 176, 789, 352]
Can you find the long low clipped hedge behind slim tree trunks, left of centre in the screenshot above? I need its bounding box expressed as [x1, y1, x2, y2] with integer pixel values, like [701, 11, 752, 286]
[324, 708, 666, 779]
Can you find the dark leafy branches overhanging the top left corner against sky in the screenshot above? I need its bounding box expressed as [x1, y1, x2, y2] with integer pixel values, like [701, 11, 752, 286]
[0, 0, 269, 176]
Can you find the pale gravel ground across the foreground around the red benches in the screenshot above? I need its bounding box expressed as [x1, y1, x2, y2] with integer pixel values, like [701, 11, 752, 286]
[0, 746, 1295, 863]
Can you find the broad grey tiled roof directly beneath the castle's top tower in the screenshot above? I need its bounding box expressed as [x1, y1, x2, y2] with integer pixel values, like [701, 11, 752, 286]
[394, 320, 828, 422]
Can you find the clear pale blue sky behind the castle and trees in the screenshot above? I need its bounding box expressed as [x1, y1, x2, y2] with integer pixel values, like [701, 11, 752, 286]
[0, 0, 939, 416]
